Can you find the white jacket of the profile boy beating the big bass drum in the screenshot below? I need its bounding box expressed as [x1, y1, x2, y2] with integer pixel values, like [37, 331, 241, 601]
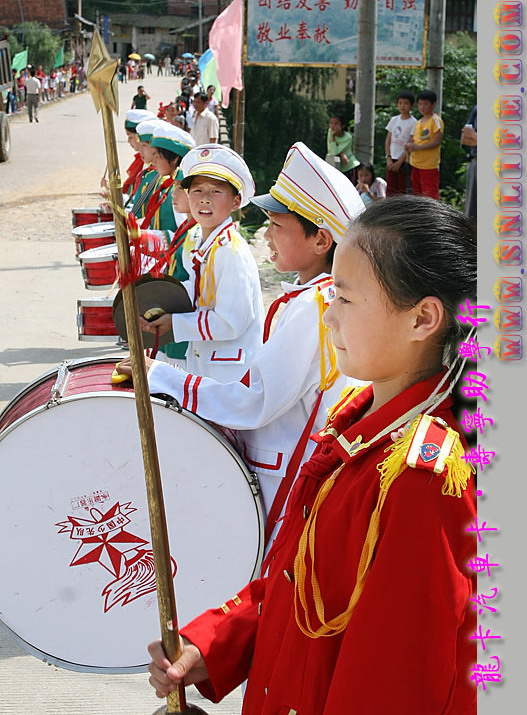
[148, 274, 361, 516]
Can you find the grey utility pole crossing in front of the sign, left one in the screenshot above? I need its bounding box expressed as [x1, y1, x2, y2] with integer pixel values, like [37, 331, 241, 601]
[355, 0, 377, 162]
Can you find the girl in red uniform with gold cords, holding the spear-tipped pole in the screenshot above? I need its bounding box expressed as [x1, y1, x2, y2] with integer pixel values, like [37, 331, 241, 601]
[149, 196, 476, 715]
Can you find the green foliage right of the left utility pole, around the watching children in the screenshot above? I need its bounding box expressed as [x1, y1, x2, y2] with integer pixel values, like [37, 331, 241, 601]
[375, 33, 477, 206]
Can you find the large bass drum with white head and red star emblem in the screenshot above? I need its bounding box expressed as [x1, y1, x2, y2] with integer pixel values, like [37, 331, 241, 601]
[0, 359, 263, 672]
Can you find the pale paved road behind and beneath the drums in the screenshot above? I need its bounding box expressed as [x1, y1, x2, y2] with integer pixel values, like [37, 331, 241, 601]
[0, 76, 241, 715]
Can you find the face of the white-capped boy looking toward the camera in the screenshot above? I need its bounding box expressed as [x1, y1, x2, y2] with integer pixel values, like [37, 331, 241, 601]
[188, 176, 241, 233]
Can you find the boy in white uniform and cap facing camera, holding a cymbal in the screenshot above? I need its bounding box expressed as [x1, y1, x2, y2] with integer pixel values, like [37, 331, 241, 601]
[137, 144, 264, 383]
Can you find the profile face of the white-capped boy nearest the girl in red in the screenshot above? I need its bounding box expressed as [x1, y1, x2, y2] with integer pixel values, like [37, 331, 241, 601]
[264, 211, 316, 273]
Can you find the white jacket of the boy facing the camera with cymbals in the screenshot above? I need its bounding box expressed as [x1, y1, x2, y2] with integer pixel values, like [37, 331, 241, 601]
[172, 217, 264, 383]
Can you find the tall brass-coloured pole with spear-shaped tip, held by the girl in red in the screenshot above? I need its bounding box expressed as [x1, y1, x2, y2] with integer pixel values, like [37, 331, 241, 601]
[87, 29, 204, 715]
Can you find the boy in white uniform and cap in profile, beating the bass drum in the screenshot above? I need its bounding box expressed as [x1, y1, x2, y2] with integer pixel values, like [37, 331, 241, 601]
[121, 142, 364, 543]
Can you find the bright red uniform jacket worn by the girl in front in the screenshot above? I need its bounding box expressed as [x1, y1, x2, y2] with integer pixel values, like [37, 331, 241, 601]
[182, 375, 476, 715]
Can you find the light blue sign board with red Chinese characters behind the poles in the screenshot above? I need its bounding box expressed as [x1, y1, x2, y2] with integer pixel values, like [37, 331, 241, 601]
[247, 0, 425, 67]
